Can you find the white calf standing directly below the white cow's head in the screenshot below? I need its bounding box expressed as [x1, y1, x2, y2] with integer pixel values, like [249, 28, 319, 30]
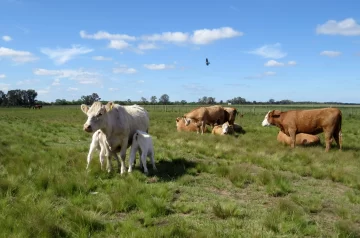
[86, 130, 119, 172]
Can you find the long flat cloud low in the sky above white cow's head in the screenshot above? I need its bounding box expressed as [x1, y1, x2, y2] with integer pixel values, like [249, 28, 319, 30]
[33, 69, 101, 84]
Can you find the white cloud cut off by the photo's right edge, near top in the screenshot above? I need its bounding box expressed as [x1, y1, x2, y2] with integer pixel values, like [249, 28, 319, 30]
[316, 18, 360, 36]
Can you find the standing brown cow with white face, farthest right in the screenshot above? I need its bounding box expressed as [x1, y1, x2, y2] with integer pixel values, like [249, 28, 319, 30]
[262, 108, 342, 152]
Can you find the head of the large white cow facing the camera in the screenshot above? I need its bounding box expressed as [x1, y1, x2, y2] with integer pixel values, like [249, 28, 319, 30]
[81, 102, 114, 132]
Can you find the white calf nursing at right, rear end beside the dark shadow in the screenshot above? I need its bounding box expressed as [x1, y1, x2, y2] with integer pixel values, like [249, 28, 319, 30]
[128, 130, 156, 174]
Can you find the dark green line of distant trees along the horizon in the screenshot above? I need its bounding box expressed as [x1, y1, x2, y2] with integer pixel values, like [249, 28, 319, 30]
[0, 89, 355, 107]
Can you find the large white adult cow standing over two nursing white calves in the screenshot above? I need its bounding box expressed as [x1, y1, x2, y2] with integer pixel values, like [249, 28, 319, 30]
[81, 102, 149, 174]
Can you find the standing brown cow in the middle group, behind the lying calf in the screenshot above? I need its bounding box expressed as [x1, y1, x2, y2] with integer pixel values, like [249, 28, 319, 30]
[183, 106, 225, 134]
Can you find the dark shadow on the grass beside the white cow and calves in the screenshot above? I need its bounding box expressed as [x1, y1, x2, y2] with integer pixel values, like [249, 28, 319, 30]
[141, 158, 197, 182]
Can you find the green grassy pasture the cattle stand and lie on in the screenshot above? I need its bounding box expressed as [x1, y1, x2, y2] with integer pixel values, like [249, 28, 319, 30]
[0, 106, 360, 237]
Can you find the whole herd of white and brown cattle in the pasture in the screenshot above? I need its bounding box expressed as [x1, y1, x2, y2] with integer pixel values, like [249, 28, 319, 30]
[81, 102, 342, 174]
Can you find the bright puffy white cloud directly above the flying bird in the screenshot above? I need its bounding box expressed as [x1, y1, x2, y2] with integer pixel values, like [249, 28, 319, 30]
[191, 27, 243, 45]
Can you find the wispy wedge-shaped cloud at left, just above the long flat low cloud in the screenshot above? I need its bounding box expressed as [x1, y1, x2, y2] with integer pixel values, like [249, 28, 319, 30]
[40, 45, 93, 65]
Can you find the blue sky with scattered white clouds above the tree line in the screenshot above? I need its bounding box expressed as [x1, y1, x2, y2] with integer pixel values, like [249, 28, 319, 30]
[0, 0, 360, 103]
